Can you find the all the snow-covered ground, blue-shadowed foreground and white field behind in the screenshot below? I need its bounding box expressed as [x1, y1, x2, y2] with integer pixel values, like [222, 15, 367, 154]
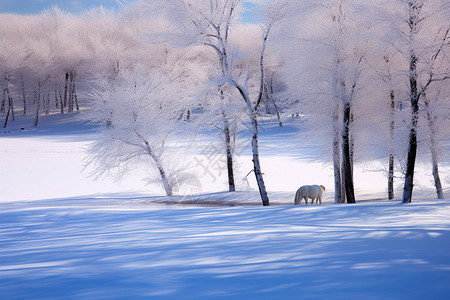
[0, 113, 450, 299]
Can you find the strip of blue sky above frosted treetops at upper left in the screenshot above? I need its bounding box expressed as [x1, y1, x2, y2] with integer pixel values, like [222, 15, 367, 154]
[0, 0, 122, 14]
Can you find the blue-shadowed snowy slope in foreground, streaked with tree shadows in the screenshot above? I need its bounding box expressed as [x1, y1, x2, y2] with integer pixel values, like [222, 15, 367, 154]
[0, 199, 450, 299]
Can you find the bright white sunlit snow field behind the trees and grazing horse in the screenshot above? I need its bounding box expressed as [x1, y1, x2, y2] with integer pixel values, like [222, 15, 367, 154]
[0, 116, 444, 204]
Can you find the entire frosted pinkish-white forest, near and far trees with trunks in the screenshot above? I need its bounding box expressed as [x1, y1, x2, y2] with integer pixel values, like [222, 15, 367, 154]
[0, 0, 450, 206]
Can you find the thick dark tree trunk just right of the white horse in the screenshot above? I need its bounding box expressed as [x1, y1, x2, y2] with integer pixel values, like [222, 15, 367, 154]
[342, 102, 356, 203]
